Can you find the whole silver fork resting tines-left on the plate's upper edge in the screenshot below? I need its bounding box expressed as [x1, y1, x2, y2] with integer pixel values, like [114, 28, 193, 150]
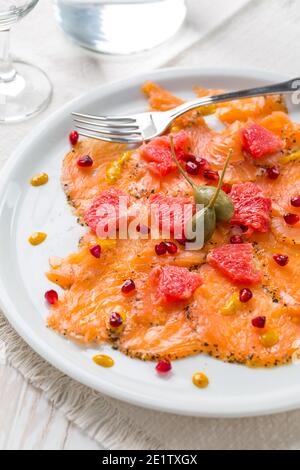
[72, 78, 300, 144]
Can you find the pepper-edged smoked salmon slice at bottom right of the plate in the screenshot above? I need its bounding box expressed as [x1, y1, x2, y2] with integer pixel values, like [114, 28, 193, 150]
[191, 264, 300, 367]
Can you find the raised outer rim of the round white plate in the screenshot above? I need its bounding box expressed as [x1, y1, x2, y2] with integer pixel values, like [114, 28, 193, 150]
[0, 67, 300, 418]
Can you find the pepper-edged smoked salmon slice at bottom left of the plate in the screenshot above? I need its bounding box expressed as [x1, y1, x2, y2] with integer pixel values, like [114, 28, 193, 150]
[48, 235, 203, 359]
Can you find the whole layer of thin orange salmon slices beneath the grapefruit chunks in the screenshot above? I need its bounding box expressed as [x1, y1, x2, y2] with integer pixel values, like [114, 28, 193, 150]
[47, 82, 300, 367]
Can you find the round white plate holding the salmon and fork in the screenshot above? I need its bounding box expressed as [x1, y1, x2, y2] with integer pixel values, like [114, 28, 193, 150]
[0, 69, 300, 417]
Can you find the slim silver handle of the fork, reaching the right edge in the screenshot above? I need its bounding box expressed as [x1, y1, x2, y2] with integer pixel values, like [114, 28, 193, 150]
[167, 78, 300, 120]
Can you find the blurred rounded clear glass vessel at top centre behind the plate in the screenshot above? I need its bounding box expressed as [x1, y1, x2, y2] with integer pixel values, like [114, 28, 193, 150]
[54, 0, 186, 54]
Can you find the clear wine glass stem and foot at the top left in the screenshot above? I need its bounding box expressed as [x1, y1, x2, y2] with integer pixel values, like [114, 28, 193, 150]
[0, 0, 52, 123]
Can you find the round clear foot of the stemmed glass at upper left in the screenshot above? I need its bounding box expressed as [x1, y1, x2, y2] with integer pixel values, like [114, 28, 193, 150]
[0, 61, 52, 123]
